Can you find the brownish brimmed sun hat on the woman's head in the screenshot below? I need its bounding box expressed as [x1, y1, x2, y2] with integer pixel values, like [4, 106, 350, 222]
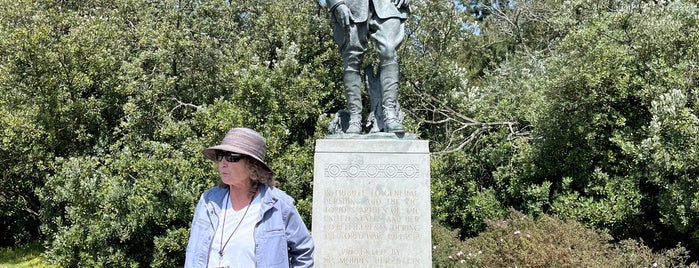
[202, 128, 272, 171]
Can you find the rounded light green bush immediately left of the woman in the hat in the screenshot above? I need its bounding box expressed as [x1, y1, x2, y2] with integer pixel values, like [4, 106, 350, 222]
[40, 139, 208, 267]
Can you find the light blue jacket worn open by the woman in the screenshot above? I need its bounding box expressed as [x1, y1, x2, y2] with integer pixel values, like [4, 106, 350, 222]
[184, 184, 314, 268]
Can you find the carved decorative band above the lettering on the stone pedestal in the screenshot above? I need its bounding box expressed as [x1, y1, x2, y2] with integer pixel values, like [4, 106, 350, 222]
[325, 164, 420, 178]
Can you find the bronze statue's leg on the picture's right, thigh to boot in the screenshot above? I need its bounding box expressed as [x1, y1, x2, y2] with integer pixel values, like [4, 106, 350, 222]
[371, 18, 405, 133]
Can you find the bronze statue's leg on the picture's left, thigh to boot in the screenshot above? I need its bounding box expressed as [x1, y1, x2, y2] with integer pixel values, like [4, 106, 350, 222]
[333, 22, 368, 134]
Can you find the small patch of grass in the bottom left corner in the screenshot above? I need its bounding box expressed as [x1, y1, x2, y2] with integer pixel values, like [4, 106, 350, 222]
[0, 242, 55, 268]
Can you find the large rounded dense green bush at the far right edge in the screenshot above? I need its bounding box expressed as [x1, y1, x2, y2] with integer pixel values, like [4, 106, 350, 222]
[532, 0, 699, 251]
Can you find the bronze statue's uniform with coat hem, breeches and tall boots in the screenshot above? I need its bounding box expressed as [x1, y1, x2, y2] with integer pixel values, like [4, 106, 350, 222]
[327, 0, 410, 132]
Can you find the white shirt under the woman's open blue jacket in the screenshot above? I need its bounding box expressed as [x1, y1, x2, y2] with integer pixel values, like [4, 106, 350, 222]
[208, 194, 260, 268]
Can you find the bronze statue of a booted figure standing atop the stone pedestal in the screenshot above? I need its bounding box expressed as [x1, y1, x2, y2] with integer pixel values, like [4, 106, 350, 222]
[327, 0, 410, 134]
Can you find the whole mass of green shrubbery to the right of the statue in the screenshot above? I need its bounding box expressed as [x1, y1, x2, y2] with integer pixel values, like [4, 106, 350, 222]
[416, 1, 699, 260]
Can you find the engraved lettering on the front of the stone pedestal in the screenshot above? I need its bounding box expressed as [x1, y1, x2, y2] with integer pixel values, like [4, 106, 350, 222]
[321, 189, 430, 260]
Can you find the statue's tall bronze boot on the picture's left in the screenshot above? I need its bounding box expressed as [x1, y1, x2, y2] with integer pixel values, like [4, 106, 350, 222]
[342, 70, 362, 134]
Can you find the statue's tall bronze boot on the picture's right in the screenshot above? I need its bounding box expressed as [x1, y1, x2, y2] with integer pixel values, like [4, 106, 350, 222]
[379, 63, 405, 133]
